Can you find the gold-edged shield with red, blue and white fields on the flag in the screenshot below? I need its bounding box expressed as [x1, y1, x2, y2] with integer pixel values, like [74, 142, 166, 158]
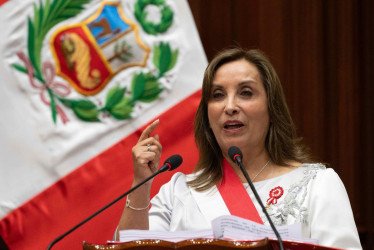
[50, 2, 150, 96]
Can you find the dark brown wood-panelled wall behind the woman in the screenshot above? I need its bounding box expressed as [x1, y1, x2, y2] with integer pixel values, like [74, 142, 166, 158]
[188, 0, 374, 249]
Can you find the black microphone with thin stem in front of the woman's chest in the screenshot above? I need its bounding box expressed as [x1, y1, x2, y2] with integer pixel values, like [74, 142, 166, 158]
[228, 146, 284, 250]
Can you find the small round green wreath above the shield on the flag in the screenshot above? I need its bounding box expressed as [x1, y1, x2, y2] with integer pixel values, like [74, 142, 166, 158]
[134, 0, 174, 35]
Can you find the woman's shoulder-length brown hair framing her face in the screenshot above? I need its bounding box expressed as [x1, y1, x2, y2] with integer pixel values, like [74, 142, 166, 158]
[188, 48, 311, 191]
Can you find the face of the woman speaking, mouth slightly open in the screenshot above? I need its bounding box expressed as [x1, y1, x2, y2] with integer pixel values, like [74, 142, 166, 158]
[208, 59, 269, 155]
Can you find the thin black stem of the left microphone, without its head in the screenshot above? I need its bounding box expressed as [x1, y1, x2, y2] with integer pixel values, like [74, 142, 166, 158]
[47, 164, 170, 250]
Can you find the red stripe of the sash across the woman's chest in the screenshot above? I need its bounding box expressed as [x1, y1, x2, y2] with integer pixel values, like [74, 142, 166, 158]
[217, 158, 264, 224]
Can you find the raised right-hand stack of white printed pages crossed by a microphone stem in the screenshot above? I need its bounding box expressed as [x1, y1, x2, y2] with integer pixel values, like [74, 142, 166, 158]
[212, 215, 318, 244]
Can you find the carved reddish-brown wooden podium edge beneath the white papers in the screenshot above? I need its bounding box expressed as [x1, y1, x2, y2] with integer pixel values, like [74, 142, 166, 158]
[83, 238, 337, 250]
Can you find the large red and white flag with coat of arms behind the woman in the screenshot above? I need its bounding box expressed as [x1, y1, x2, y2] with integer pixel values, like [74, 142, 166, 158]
[0, 0, 207, 249]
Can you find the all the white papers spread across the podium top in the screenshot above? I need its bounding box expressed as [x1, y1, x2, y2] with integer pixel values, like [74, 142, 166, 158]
[119, 215, 318, 244]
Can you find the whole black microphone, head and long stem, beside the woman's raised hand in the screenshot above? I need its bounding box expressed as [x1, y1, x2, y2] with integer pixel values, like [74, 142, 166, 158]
[47, 155, 183, 250]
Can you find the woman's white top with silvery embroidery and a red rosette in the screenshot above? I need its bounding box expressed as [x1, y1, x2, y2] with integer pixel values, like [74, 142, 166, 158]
[149, 164, 362, 249]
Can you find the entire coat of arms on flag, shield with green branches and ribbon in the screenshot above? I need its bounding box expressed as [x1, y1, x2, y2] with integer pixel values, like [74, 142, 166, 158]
[12, 0, 179, 123]
